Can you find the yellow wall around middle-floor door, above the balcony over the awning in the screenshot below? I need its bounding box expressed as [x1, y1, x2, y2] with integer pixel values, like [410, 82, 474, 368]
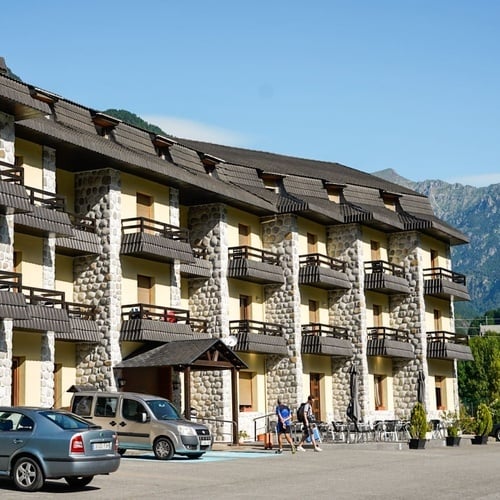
[121, 256, 170, 307]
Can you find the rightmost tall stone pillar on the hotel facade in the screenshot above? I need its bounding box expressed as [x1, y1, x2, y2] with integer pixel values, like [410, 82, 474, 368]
[388, 232, 428, 418]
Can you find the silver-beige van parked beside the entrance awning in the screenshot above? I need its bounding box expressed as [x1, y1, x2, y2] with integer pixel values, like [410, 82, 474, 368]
[71, 391, 212, 460]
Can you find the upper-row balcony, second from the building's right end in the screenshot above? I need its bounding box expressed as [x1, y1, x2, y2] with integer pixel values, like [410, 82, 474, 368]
[364, 260, 410, 295]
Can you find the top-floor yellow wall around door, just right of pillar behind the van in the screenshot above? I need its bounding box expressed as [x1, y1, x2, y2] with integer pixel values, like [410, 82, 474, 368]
[121, 174, 170, 224]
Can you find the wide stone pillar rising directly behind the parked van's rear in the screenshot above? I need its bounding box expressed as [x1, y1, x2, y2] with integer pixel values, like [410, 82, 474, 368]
[74, 169, 122, 390]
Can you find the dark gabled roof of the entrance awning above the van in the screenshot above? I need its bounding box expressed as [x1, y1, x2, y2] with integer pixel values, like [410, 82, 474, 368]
[115, 338, 247, 370]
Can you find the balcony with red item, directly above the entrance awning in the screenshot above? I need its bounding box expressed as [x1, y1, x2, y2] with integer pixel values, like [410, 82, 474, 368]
[120, 304, 207, 342]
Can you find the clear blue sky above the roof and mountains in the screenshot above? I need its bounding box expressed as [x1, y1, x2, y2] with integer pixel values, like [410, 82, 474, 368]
[0, 0, 500, 186]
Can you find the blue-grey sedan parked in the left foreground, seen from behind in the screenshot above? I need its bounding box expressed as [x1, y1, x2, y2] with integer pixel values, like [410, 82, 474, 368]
[0, 406, 120, 491]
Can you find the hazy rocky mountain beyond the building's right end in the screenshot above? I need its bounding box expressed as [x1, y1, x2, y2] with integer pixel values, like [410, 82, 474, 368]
[373, 169, 500, 318]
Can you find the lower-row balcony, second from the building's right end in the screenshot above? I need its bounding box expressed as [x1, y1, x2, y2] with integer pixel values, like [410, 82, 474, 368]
[366, 326, 415, 359]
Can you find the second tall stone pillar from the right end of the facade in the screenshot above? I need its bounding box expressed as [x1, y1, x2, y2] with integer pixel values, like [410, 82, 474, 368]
[327, 224, 369, 420]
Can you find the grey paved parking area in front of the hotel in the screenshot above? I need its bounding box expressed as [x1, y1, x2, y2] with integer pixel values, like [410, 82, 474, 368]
[0, 439, 500, 500]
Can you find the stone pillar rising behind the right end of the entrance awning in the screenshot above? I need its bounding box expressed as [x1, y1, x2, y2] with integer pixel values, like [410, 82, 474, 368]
[188, 204, 228, 440]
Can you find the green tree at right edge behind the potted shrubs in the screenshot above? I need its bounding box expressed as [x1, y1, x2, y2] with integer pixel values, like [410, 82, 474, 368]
[458, 333, 500, 413]
